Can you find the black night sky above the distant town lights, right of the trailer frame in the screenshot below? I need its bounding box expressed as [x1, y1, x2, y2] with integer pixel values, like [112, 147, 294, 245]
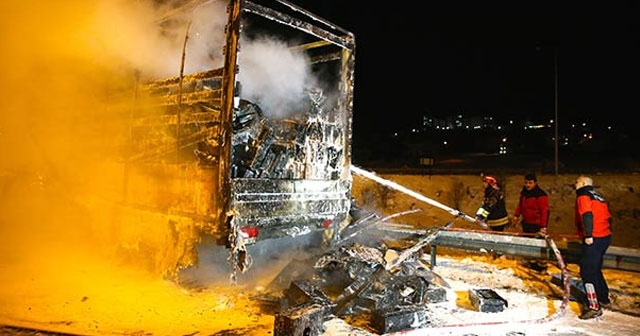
[292, 0, 640, 134]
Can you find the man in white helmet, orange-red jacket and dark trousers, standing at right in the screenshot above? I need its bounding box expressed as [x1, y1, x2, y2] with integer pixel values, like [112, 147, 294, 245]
[575, 175, 612, 320]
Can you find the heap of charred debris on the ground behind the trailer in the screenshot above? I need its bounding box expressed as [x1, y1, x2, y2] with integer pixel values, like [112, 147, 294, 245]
[272, 242, 448, 335]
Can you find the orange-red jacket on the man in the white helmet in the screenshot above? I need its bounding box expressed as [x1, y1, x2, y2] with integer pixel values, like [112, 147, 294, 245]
[575, 186, 611, 238]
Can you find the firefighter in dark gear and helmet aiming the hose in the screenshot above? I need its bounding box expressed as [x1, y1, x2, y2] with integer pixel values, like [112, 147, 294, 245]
[476, 175, 509, 231]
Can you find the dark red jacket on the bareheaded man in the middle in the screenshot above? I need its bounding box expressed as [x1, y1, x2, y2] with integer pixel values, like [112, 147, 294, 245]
[514, 185, 549, 228]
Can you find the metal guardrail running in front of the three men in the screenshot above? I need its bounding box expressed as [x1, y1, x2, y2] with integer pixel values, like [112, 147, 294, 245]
[430, 229, 640, 272]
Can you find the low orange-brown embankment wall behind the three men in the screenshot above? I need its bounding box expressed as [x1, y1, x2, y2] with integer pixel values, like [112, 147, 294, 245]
[353, 174, 640, 248]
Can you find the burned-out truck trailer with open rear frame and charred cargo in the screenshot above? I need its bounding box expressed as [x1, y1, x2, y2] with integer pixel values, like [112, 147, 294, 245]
[121, 0, 355, 276]
